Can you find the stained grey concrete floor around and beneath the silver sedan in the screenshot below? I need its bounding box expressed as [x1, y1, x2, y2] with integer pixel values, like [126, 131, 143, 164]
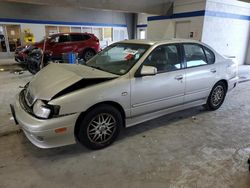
[0, 61, 250, 188]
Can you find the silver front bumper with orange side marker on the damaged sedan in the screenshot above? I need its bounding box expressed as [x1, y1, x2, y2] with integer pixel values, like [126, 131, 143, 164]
[12, 96, 79, 148]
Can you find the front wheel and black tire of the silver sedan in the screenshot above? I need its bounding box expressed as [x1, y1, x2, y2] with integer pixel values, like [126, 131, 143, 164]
[77, 105, 123, 150]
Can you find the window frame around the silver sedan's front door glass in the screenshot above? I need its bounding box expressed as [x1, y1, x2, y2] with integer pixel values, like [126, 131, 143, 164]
[138, 43, 185, 75]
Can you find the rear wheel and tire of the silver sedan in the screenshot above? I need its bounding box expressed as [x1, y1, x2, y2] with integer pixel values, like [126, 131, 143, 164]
[204, 81, 227, 110]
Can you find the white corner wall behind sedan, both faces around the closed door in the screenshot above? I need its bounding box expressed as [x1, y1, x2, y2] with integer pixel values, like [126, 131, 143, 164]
[147, 0, 250, 64]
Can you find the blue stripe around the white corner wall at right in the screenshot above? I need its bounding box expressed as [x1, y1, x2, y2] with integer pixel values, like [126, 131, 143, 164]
[148, 10, 250, 21]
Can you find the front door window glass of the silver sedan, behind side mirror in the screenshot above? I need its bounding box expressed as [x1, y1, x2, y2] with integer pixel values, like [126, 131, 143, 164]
[143, 45, 181, 73]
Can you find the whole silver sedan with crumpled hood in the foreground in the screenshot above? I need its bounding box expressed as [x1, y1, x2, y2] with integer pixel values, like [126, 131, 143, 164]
[11, 39, 238, 149]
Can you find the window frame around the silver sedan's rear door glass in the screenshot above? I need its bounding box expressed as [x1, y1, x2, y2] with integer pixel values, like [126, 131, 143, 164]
[181, 42, 216, 69]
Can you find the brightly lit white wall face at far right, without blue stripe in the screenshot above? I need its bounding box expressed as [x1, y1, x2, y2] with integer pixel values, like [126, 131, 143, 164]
[202, 0, 250, 64]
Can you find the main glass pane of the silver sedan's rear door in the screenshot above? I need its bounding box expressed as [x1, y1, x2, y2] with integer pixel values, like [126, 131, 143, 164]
[183, 44, 207, 68]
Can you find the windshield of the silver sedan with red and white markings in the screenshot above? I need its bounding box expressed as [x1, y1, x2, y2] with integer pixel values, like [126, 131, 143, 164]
[86, 43, 150, 75]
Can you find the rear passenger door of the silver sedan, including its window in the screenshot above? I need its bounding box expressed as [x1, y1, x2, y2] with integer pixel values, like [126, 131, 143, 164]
[182, 43, 217, 103]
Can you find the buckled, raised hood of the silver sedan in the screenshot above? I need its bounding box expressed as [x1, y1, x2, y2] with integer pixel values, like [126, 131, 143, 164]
[27, 63, 118, 102]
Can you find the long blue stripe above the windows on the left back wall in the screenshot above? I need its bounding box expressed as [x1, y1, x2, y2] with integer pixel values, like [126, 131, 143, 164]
[0, 18, 127, 27]
